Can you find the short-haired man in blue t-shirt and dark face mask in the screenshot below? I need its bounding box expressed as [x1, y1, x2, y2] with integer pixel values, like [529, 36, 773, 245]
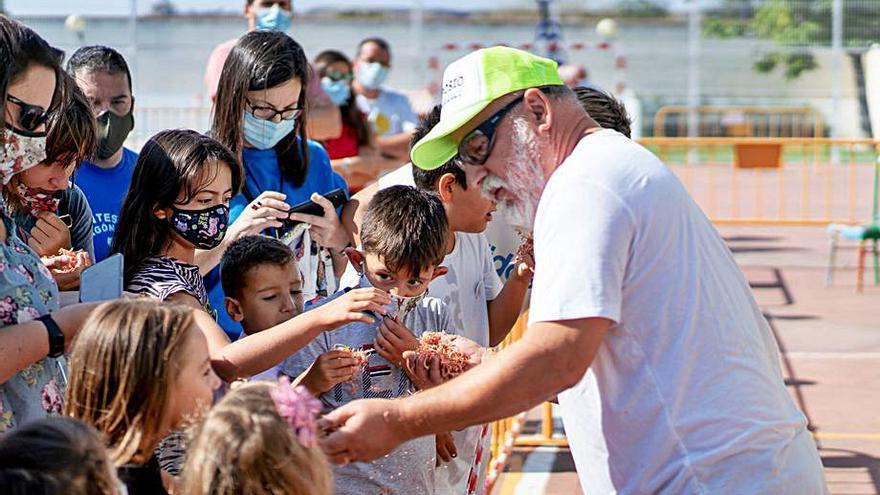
[67, 45, 138, 262]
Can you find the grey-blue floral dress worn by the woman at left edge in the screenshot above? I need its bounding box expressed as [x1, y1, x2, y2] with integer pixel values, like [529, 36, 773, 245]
[0, 212, 67, 433]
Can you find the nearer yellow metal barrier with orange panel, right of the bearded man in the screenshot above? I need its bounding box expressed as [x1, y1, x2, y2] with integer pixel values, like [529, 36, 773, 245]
[640, 137, 880, 225]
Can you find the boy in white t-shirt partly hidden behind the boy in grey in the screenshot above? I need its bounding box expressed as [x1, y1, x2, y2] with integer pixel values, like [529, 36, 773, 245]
[341, 107, 531, 495]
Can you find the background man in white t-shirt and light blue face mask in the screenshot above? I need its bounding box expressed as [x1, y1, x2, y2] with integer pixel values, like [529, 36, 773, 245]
[351, 38, 419, 162]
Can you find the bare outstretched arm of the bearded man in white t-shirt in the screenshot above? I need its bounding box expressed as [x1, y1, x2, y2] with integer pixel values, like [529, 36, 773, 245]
[323, 318, 611, 463]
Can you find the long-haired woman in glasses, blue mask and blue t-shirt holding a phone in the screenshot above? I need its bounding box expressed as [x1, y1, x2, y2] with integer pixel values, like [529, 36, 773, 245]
[209, 31, 351, 334]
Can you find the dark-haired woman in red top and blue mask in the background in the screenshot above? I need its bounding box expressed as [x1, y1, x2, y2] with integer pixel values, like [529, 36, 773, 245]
[315, 50, 400, 193]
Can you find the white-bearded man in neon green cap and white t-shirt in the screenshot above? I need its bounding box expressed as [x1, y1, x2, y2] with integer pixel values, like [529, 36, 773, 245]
[323, 47, 827, 494]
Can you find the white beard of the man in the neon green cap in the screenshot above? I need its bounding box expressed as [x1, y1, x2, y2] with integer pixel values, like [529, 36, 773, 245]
[482, 116, 546, 232]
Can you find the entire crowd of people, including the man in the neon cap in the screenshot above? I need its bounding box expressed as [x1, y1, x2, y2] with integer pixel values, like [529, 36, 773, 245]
[0, 0, 823, 495]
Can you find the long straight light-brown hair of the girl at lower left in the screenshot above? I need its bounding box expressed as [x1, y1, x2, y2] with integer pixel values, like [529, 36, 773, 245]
[65, 299, 198, 466]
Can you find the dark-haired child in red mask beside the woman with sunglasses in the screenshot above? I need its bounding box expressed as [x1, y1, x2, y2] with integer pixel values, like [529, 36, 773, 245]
[3, 72, 97, 290]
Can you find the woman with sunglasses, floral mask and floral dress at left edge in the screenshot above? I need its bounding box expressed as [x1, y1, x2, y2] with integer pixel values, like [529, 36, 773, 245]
[0, 15, 99, 433]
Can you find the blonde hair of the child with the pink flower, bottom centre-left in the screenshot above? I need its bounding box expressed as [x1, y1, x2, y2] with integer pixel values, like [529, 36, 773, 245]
[182, 382, 333, 495]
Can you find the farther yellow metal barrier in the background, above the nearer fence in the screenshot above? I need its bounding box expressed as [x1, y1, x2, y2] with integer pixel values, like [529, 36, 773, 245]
[654, 106, 824, 138]
